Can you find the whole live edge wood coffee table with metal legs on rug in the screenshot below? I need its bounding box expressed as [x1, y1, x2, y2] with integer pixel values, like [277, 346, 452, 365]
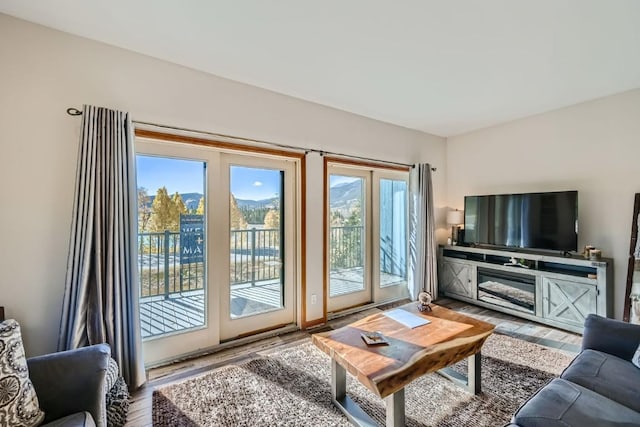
[312, 303, 494, 427]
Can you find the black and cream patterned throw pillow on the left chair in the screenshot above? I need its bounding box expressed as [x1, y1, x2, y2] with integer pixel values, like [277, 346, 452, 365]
[0, 319, 44, 427]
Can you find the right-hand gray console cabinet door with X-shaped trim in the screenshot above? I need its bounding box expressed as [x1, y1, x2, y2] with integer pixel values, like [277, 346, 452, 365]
[542, 276, 598, 327]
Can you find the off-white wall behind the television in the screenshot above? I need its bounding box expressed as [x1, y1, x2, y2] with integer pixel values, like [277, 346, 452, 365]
[447, 90, 640, 318]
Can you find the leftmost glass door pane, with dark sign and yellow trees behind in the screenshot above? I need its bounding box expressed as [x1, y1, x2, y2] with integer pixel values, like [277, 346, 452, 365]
[136, 155, 207, 339]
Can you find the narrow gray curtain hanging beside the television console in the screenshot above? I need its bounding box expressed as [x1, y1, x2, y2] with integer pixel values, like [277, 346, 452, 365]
[409, 163, 438, 299]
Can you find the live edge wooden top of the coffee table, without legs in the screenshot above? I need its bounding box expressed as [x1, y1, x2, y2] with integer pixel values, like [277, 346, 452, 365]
[312, 302, 494, 398]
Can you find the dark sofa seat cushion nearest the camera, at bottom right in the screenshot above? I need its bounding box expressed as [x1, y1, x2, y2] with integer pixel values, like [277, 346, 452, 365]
[512, 378, 640, 427]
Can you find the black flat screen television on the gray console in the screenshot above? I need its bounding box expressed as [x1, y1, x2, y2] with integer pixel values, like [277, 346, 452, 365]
[463, 191, 578, 251]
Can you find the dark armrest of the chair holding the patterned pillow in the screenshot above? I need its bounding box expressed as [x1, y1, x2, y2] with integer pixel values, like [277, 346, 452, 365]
[27, 344, 111, 427]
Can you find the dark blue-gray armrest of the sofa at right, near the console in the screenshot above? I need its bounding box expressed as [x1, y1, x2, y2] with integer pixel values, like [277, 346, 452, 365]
[582, 314, 640, 361]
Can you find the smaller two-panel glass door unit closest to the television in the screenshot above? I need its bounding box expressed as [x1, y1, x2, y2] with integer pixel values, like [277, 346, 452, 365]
[325, 162, 409, 312]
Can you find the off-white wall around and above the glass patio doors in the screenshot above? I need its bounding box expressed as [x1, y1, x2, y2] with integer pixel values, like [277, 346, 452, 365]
[0, 14, 445, 355]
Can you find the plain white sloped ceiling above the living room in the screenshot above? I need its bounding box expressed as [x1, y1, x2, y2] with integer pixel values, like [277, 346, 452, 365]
[0, 0, 640, 136]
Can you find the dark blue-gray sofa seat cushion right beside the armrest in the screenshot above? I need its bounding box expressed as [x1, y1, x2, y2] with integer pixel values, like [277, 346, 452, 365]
[560, 350, 640, 412]
